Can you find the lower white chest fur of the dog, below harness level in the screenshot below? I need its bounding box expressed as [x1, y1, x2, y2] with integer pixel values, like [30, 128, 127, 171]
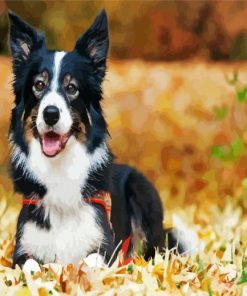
[21, 205, 103, 265]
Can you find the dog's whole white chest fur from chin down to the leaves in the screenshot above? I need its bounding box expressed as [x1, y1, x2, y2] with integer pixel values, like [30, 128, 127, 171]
[17, 137, 108, 264]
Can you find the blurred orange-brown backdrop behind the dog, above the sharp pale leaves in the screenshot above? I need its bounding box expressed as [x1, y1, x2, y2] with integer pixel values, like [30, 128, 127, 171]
[0, 1, 247, 213]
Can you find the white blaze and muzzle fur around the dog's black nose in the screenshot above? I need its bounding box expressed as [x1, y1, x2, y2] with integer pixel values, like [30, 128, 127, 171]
[36, 51, 73, 135]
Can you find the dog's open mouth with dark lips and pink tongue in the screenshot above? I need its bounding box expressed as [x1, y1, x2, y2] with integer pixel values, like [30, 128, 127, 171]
[40, 132, 70, 157]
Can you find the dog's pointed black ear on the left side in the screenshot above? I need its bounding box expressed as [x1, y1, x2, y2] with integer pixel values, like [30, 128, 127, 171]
[8, 11, 45, 66]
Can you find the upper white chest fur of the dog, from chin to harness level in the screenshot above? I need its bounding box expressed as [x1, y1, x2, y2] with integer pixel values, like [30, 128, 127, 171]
[27, 136, 108, 211]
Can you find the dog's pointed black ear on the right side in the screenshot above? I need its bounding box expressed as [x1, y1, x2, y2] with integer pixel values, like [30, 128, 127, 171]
[75, 9, 109, 76]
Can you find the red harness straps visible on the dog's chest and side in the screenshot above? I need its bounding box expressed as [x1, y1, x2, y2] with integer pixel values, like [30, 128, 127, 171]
[22, 191, 133, 265]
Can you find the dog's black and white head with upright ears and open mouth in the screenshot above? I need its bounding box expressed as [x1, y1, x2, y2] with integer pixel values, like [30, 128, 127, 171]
[9, 10, 109, 157]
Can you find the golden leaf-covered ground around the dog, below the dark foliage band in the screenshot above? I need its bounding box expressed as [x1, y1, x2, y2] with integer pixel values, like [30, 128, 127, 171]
[0, 58, 247, 295]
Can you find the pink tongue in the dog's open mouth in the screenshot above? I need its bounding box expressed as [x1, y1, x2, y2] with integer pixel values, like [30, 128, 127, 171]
[42, 133, 61, 156]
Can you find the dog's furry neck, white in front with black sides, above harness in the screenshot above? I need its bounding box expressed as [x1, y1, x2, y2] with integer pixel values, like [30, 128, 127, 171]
[12, 137, 112, 209]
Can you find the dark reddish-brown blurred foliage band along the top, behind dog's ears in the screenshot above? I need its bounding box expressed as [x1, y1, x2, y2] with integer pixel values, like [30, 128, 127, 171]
[0, 0, 247, 61]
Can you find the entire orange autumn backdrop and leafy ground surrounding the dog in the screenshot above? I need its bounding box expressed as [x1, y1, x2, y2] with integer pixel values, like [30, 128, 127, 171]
[0, 0, 247, 295]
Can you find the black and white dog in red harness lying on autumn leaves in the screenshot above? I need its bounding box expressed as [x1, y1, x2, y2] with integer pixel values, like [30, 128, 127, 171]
[9, 11, 183, 266]
